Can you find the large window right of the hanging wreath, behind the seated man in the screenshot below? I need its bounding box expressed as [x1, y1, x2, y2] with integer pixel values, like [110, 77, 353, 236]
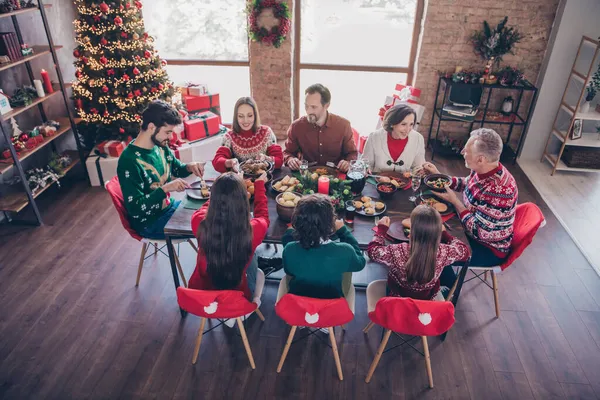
[294, 0, 423, 134]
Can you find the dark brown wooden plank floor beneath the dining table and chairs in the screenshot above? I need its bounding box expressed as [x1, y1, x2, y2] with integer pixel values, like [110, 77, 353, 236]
[0, 160, 600, 400]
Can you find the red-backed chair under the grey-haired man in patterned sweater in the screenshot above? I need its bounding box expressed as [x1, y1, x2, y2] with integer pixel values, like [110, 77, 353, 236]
[448, 203, 546, 318]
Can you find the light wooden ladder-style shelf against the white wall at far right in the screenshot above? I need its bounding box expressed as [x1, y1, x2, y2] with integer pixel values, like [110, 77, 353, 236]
[540, 36, 600, 175]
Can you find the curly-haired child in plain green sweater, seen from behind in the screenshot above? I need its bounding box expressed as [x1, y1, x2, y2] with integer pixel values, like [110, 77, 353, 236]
[278, 194, 365, 299]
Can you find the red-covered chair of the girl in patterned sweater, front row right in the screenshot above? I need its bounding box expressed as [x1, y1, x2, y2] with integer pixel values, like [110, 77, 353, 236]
[363, 280, 454, 388]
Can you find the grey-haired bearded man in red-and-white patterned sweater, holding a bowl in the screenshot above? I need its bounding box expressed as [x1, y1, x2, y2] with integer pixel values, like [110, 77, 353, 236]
[424, 128, 518, 267]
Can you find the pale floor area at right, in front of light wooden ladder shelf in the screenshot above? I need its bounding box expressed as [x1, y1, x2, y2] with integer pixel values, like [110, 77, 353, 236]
[519, 160, 600, 273]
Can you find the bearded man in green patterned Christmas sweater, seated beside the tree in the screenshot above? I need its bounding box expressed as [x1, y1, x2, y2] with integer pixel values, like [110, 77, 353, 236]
[117, 100, 204, 239]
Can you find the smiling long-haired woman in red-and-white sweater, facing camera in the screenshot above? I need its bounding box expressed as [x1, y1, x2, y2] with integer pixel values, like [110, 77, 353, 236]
[213, 97, 283, 172]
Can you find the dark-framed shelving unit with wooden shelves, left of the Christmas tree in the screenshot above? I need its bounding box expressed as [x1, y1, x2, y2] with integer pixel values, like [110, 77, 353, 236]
[0, 0, 85, 225]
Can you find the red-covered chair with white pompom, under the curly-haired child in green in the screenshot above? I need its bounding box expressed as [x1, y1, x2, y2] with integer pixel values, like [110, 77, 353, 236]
[275, 293, 354, 381]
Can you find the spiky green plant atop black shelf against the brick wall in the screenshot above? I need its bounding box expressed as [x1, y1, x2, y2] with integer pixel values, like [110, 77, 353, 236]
[471, 17, 523, 70]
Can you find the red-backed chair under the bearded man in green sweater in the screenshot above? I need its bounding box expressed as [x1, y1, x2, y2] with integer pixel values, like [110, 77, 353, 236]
[105, 176, 198, 287]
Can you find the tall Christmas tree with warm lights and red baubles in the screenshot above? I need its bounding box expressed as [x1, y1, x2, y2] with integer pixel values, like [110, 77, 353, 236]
[73, 0, 174, 146]
